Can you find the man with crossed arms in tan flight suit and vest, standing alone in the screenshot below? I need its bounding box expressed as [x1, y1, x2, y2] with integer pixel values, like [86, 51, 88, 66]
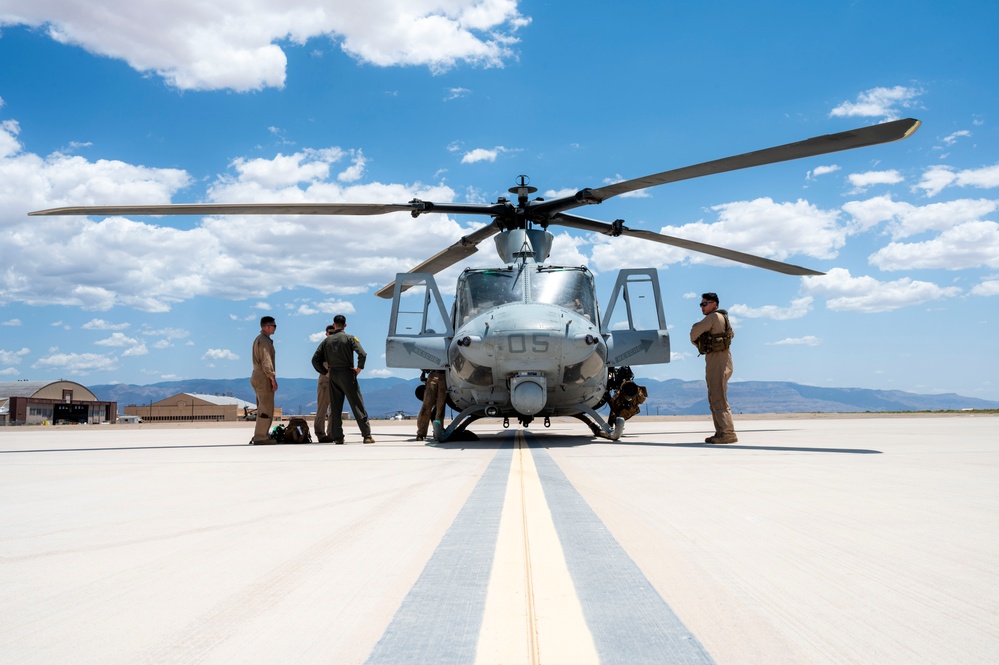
[690, 293, 739, 443]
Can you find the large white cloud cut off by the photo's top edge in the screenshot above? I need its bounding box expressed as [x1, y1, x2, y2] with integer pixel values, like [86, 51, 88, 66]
[0, 0, 530, 91]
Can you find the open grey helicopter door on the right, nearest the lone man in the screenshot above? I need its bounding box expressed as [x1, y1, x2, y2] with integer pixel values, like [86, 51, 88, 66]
[600, 268, 669, 367]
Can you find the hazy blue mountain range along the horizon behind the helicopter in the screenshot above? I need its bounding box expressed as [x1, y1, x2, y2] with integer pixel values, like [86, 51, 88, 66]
[89, 378, 999, 418]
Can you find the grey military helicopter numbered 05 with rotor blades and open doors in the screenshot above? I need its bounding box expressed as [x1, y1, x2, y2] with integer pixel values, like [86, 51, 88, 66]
[28, 118, 920, 442]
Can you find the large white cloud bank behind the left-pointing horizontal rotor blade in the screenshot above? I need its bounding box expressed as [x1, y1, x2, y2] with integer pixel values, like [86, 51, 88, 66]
[0, 119, 490, 312]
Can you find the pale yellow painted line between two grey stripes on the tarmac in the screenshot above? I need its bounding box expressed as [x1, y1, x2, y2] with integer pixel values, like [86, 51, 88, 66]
[475, 431, 599, 665]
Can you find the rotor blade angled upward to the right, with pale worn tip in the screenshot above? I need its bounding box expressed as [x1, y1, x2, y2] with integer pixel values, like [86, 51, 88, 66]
[531, 118, 920, 214]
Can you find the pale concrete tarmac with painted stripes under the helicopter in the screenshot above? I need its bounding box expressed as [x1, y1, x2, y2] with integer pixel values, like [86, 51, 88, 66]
[0, 414, 999, 665]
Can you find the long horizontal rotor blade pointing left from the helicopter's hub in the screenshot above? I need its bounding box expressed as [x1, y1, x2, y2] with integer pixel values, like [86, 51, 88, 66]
[28, 203, 418, 216]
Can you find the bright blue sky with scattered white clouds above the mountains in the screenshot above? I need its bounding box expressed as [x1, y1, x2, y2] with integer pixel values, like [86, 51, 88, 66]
[0, 0, 999, 400]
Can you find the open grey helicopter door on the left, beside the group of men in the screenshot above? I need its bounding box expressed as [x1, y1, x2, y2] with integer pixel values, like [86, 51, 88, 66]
[385, 272, 454, 369]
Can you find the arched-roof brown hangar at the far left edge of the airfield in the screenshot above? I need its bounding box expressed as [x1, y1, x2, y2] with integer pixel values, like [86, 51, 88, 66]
[0, 380, 118, 425]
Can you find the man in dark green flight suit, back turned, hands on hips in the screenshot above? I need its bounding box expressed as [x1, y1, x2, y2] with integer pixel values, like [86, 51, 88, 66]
[312, 314, 375, 443]
